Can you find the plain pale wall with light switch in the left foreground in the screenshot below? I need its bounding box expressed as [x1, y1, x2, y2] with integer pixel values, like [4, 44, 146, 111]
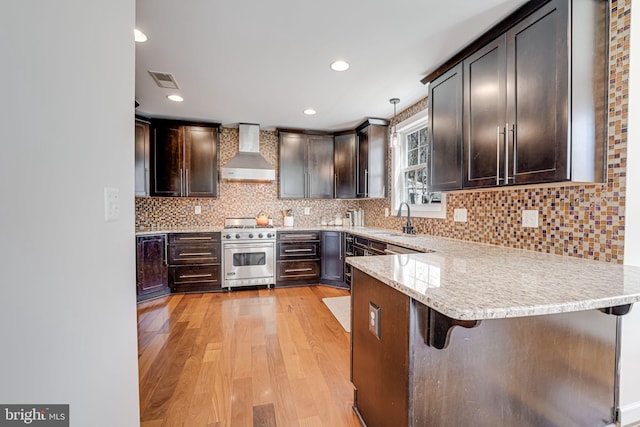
[0, 0, 139, 427]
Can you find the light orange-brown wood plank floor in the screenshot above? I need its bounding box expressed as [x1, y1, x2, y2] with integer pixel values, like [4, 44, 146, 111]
[138, 286, 360, 427]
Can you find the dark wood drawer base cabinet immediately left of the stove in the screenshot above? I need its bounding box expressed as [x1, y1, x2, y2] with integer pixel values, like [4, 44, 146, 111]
[167, 233, 222, 292]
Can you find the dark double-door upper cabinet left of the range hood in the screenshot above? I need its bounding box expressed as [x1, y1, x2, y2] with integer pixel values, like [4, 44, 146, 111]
[152, 120, 218, 197]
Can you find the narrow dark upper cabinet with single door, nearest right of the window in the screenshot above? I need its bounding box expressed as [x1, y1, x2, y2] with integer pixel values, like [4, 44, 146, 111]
[429, 64, 462, 191]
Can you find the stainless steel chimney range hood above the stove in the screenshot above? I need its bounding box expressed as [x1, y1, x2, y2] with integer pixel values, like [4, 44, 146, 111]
[220, 123, 276, 182]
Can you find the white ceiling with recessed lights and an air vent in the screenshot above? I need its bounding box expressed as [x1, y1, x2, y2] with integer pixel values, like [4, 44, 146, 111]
[136, 0, 525, 131]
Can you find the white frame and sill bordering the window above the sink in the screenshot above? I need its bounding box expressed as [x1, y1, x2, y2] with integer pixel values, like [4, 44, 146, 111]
[391, 109, 447, 219]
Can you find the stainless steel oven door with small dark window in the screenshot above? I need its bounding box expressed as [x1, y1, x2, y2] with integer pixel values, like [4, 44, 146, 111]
[223, 243, 275, 287]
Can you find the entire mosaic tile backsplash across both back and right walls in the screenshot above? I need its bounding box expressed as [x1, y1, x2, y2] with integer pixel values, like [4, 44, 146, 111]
[136, 0, 631, 263]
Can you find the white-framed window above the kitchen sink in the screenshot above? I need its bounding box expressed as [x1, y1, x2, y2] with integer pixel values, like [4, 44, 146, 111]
[392, 110, 446, 218]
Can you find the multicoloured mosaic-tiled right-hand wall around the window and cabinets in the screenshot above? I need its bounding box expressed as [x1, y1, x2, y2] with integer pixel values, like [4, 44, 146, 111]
[360, 0, 631, 263]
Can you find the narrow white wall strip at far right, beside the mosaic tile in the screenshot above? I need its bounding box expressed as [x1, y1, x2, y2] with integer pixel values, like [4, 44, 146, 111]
[620, 1, 640, 425]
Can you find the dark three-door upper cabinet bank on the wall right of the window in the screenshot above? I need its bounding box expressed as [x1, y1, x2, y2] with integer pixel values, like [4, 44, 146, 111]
[429, 0, 607, 190]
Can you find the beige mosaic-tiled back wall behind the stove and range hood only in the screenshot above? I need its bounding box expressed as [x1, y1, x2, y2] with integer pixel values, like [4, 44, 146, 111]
[135, 127, 358, 229]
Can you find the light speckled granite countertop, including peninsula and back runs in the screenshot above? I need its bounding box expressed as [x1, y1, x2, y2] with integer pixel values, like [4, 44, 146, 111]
[136, 226, 640, 320]
